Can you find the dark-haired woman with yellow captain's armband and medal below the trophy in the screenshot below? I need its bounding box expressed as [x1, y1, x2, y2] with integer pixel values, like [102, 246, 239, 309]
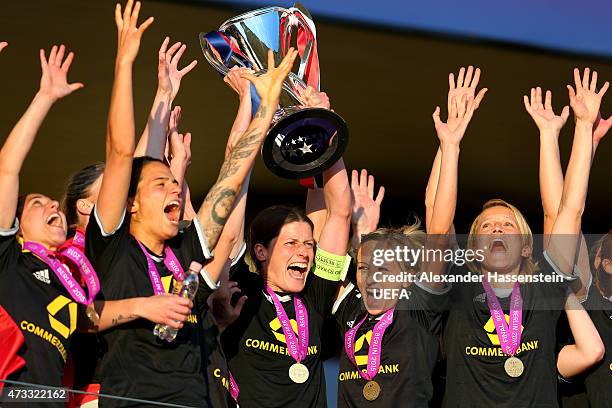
[222, 82, 351, 407]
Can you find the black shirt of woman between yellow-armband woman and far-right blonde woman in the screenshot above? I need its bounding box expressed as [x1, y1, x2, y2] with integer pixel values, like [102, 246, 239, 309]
[333, 284, 448, 407]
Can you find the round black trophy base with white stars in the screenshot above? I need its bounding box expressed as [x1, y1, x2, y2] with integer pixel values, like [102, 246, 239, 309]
[261, 108, 348, 180]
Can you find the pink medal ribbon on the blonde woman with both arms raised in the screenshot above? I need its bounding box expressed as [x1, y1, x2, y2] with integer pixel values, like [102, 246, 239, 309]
[482, 279, 523, 356]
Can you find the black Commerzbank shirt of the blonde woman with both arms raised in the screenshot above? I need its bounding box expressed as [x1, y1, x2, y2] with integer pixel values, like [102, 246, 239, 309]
[443, 259, 567, 408]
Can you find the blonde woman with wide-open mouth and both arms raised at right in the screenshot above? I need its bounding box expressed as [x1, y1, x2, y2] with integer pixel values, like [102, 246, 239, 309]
[431, 65, 608, 407]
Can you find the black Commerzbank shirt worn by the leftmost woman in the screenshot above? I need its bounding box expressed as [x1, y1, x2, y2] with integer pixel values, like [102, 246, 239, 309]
[0, 222, 79, 407]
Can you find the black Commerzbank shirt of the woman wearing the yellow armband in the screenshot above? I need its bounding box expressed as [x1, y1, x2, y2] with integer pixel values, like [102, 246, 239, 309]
[221, 261, 338, 408]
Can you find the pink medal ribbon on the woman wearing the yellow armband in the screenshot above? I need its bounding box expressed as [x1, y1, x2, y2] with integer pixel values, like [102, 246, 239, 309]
[266, 285, 308, 363]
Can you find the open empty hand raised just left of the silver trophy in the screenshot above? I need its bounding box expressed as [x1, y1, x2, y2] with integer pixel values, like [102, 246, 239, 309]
[157, 37, 198, 100]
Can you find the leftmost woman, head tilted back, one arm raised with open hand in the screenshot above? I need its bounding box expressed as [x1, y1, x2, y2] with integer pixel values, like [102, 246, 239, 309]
[0, 45, 87, 406]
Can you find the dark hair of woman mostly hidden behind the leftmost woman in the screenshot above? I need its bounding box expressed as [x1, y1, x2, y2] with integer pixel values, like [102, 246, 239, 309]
[62, 162, 104, 233]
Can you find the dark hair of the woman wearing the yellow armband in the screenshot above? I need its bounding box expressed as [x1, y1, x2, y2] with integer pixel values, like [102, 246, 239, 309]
[247, 205, 314, 272]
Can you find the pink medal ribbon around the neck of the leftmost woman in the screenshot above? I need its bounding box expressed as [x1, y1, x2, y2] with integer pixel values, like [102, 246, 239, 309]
[23, 242, 100, 306]
